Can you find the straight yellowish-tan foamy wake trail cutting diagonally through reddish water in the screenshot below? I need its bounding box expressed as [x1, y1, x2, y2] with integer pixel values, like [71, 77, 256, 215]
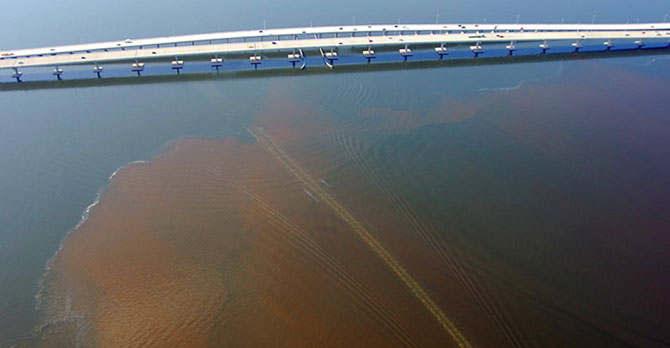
[249, 127, 472, 348]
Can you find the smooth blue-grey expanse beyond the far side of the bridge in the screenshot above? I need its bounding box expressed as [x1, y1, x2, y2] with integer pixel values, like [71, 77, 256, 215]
[0, 0, 670, 50]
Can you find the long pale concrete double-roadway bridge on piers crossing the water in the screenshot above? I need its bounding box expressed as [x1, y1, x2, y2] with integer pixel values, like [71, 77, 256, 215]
[0, 23, 670, 82]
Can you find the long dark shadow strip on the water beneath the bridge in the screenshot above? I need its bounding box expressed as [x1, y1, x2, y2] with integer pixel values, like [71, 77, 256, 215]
[0, 47, 670, 91]
